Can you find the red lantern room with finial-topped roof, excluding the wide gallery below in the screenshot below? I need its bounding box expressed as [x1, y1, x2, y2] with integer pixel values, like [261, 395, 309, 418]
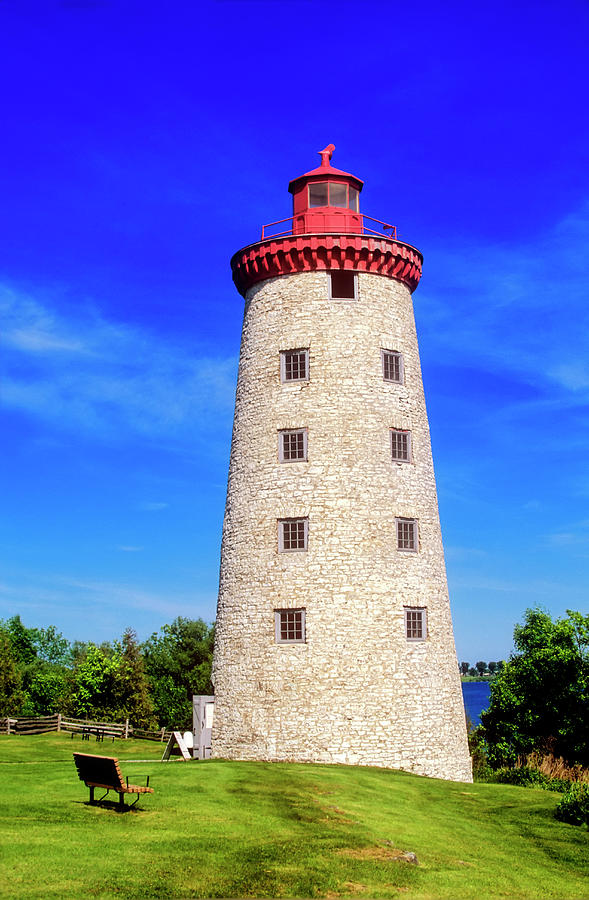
[288, 144, 364, 234]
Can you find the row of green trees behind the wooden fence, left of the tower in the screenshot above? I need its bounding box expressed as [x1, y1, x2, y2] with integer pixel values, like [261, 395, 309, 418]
[0, 616, 214, 729]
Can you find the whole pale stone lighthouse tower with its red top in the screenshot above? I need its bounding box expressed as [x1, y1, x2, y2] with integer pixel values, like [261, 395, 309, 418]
[212, 145, 471, 781]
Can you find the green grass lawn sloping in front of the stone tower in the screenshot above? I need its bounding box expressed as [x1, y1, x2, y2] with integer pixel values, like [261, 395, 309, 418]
[0, 734, 589, 900]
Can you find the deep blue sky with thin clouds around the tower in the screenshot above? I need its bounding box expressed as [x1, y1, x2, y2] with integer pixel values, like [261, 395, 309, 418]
[0, 0, 589, 661]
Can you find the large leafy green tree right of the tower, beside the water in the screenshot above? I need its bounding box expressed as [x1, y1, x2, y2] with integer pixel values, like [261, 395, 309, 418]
[481, 609, 589, 767]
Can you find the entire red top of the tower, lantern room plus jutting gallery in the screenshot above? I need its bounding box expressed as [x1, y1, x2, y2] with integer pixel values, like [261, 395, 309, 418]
[231, 144, 422, 296]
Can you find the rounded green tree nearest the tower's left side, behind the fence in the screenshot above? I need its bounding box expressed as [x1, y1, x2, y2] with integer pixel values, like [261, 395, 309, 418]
[142, 617, 214, 728]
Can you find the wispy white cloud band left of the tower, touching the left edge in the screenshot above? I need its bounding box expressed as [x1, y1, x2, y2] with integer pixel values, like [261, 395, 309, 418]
[0, 286, 236, 440]
